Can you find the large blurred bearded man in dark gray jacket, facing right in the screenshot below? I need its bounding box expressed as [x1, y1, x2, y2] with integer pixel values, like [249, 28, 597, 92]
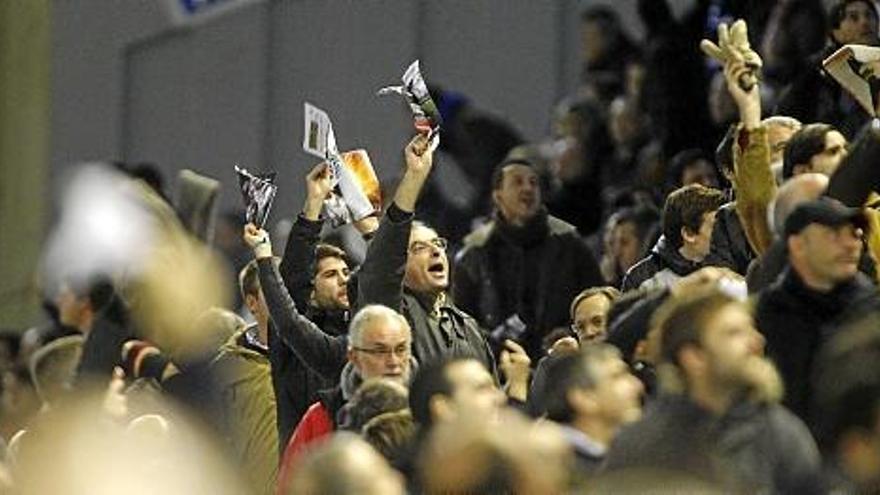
[606, 286, 819, 493]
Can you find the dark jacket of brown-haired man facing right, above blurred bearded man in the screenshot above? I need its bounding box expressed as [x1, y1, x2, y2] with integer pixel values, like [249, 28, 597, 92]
[621, 236, 703, 292]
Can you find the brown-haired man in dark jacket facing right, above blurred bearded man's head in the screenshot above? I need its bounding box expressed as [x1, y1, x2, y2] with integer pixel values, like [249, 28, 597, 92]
[622, 184, 724, 291]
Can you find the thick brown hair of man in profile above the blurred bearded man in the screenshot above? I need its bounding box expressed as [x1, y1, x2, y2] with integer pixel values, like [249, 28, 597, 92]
[661, 184, 724, 249]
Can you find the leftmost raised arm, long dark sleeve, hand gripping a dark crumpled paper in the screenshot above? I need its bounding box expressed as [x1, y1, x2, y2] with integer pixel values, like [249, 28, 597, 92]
[244, 224, 348, 380]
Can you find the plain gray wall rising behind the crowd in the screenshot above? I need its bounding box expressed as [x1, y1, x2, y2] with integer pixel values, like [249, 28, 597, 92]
[51, 0, 634, 225]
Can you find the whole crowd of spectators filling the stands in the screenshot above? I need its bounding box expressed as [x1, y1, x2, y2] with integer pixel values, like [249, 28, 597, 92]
[0, 0, 880, 495]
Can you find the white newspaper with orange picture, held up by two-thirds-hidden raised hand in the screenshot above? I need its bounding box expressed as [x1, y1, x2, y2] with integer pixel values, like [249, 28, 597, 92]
[303, 103, 382, 227]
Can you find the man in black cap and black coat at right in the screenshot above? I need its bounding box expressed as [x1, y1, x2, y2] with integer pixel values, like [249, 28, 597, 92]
[755, 198, 880, 419]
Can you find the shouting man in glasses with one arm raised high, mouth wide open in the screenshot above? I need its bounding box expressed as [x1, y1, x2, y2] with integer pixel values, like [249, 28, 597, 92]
[358, 135, 528, 388]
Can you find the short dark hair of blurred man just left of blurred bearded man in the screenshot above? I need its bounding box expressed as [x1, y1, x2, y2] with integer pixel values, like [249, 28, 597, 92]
[544, 344, 620, 423]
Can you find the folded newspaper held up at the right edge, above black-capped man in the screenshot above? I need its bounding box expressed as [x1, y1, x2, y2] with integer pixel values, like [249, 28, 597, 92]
[822, 45, 880, 117]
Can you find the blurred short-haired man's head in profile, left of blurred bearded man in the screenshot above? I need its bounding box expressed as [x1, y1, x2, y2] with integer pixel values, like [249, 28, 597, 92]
[544, 344, 644, 478]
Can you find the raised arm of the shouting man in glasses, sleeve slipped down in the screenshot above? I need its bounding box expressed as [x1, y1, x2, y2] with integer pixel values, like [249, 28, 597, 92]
[358, 134, 434, 310]
